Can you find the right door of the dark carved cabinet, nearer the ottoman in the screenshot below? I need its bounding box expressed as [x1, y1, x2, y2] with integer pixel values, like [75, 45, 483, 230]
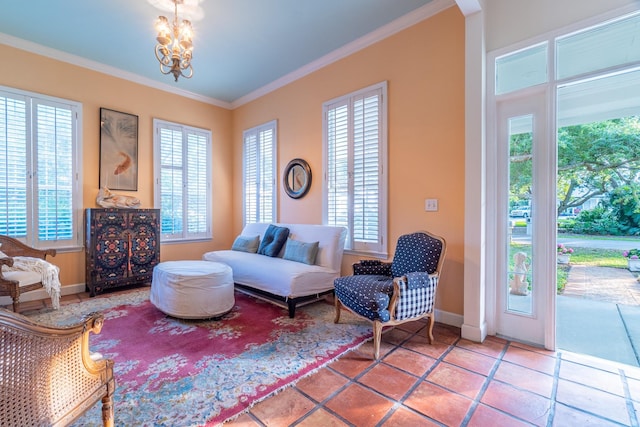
[129, 210, 160, 276]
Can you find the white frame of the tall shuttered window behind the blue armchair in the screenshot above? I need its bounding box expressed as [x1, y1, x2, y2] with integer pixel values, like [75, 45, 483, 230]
[322, 81, 388, 259]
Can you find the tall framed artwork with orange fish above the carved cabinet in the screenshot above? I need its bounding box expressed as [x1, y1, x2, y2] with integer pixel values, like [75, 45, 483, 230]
[100, 108, 138, 191]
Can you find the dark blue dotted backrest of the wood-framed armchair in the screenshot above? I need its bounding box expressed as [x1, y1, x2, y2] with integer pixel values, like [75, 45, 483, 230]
[391, 231, 446, 277]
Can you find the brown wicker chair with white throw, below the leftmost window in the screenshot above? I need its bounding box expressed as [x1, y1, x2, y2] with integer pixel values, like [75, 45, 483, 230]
[0, 235, 56, 312]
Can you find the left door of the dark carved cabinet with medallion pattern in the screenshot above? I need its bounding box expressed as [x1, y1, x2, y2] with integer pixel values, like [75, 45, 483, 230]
[91, 210, 129, 283]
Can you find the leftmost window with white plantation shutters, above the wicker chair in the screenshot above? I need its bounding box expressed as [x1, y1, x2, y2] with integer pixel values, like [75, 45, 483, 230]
[0, 87, 82, 248]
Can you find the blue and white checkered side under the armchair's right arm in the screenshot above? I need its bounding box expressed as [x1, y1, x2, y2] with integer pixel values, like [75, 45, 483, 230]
[389, 272, 440, 320]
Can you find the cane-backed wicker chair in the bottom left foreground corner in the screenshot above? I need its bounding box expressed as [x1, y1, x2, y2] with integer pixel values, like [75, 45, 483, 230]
[0, 308, 115, 427]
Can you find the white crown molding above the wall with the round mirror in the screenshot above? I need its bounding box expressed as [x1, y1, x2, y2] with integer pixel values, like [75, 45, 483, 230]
[231, 0, 456, 109]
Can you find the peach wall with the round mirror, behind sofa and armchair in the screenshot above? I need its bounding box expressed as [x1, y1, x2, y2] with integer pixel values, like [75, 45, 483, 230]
[232, 7, 465, 314]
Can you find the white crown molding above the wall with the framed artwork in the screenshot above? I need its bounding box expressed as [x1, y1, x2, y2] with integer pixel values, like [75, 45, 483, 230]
[0, 33, 231, 109]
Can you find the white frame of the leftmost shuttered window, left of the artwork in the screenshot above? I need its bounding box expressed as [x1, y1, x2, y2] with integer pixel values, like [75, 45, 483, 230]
[0, 86, 83, 251]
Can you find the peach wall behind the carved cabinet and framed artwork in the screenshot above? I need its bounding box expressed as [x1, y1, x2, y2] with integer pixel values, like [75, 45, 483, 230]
[0, 44, 234, 292]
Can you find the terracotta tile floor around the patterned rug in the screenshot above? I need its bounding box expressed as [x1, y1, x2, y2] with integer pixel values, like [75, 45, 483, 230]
[8, 293, 640, 427]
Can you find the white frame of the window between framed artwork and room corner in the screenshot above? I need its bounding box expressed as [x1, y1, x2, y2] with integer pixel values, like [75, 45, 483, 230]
[153, 119, 212, 244]
